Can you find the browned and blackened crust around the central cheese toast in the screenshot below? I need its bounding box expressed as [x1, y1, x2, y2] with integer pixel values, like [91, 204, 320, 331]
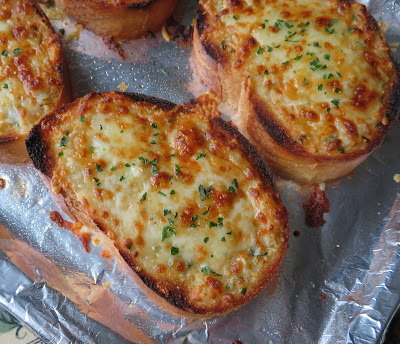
[26, 92, 289, 318]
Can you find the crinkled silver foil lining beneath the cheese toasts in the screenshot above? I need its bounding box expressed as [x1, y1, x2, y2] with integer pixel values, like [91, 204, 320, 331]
[0, 0, 400, 344]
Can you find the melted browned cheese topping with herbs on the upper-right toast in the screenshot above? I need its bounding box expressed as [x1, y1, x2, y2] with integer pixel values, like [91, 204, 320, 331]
[201, 0, 396, 155]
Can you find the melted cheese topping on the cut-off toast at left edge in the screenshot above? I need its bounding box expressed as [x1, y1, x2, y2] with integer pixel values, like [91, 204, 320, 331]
[0, 0, 63, 138]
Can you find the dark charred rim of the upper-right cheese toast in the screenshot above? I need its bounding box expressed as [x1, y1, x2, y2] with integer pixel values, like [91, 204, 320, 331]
[194, 0, 400, 162]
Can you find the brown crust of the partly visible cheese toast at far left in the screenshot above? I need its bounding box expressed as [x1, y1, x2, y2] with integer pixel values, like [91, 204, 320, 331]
[0, 0, 71, 163]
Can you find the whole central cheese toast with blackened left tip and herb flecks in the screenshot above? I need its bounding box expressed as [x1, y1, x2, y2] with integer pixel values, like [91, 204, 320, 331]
[26, 92, 288, 317]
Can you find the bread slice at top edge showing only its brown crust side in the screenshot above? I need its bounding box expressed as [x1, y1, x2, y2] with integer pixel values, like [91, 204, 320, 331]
[55, 0, 178, 41]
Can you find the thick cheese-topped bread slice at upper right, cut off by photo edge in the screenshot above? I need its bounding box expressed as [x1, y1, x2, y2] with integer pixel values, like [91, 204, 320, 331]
[194, 0, 400, 183]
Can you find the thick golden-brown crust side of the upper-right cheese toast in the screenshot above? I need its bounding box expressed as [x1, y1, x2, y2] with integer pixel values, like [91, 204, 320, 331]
[193, 0, 400, 184]
